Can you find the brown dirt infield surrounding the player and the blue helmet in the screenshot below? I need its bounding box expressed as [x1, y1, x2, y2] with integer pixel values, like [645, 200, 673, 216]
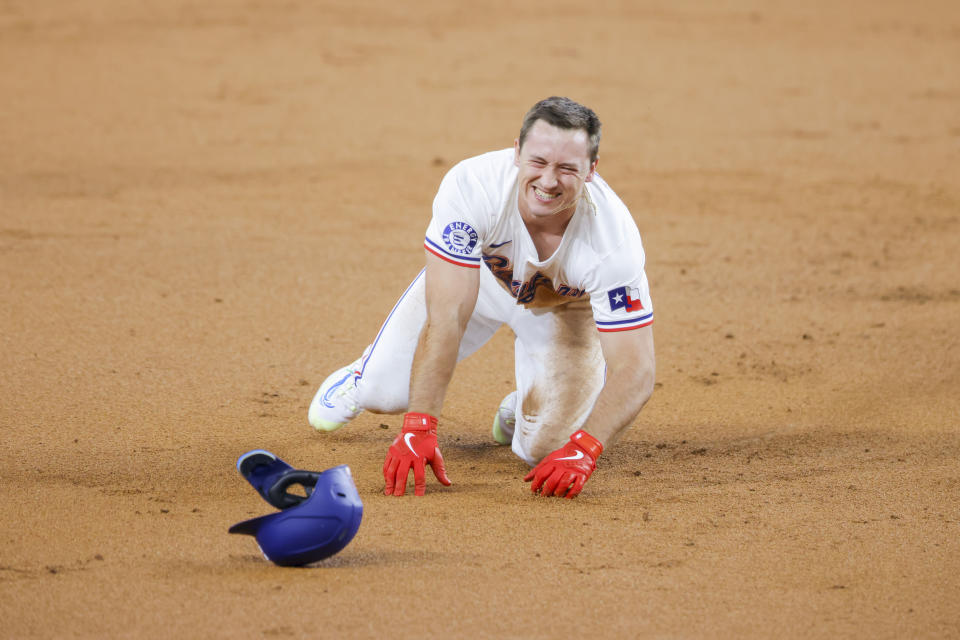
[0, 0, 960, 638]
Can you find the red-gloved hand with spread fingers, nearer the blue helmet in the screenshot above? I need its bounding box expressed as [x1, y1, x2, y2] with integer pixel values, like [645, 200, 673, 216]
[383, 413, 450, 496]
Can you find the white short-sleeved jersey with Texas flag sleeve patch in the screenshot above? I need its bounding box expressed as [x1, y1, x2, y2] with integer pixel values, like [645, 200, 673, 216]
[424, 148, 653, 331]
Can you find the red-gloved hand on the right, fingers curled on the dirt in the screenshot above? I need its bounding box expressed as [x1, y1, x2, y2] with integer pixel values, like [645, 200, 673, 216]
[523, 429, 603, 498]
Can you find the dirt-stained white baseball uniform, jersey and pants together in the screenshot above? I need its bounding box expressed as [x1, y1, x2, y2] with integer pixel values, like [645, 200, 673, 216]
[346, 148, 653, 465]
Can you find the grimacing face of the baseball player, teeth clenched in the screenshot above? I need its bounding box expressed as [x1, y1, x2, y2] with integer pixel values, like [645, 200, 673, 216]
[514, 120, 597, 220]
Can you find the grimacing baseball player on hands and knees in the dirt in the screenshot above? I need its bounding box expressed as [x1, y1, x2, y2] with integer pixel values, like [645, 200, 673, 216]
[309, 97, 654, 498]
